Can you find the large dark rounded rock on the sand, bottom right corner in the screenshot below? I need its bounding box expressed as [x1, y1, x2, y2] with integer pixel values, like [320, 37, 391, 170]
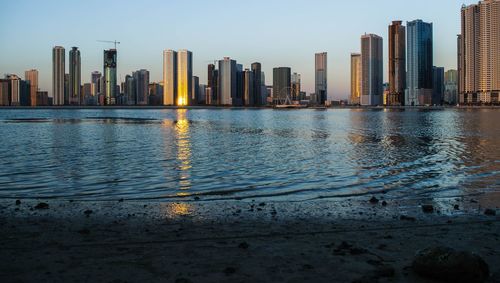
[412, 247, 489, 283]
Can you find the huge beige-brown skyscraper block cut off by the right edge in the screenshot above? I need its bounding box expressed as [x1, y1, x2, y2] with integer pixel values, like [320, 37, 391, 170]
[458, 0, 500, 104]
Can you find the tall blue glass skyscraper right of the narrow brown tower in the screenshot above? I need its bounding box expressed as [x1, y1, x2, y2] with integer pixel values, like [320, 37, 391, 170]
[405, 20, 433, 106]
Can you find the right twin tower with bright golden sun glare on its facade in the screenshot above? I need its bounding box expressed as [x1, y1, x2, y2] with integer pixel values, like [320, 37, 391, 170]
[176, 50, 193, 106]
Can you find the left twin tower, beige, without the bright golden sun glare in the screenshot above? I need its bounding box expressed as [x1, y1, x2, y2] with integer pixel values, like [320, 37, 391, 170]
[163, 49, 177, 105]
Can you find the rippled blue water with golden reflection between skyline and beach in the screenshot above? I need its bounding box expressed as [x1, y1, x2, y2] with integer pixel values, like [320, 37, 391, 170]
[0, 109, 500, 201]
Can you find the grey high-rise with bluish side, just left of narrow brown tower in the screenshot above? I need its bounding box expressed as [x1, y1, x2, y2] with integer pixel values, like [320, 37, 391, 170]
[361, 34, 384, 105]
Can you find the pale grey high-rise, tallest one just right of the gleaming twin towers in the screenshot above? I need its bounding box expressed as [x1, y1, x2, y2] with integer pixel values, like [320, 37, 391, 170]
[218, 57, 237, 105]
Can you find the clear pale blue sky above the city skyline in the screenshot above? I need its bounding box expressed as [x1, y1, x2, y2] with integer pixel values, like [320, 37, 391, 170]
[0, 0, 477, 99]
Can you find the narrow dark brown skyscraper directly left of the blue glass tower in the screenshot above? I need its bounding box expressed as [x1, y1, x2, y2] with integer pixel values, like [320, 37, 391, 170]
[387, 21, 406, 105]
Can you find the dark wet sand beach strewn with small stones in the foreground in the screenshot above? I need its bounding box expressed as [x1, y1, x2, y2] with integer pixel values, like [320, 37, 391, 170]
[0, 198, 500, 283]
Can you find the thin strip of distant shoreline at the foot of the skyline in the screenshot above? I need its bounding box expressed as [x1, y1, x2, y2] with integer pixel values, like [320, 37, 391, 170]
[0, 105, 500, 110]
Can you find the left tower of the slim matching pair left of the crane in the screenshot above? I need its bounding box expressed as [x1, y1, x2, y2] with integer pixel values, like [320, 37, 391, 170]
[52, 46, 66, 105]
